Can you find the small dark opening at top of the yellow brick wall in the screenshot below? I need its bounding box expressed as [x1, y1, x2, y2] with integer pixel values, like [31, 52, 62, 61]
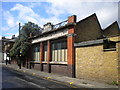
[103, 39, 116, 51]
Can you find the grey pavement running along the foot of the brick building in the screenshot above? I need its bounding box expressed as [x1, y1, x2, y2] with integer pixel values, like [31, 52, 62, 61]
[2, 63, 118, 89]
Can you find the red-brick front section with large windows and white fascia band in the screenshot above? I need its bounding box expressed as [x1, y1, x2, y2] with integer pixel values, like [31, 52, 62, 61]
[30, 15, 76, 77]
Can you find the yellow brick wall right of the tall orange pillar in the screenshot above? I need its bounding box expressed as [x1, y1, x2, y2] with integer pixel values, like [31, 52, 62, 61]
[76, 45, 118, 83]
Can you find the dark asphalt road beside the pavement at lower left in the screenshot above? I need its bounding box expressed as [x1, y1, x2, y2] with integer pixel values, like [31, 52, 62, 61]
[0, 67, 72, 90]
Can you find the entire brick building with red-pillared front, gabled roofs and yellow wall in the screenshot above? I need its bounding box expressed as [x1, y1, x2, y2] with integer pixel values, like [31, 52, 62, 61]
[11, 14, 120, 82]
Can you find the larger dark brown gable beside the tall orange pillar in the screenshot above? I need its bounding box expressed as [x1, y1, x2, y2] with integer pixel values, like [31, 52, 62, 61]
[75, 13, 102, 42]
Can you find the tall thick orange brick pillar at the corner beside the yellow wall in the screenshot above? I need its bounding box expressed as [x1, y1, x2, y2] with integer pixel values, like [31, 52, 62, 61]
[67, 15, 76, 78]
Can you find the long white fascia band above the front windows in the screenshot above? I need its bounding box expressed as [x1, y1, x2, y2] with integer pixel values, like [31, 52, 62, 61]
[32, 29, 68, 44]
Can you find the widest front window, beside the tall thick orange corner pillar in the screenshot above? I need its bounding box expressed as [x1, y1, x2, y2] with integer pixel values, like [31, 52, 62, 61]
[51, 40, 67, 62]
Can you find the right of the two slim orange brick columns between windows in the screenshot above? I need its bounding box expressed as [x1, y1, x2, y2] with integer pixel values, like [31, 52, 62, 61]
[47, 41, 51, 73]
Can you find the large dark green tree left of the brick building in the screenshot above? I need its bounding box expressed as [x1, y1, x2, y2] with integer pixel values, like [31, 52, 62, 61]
[10, 22, 41, 58]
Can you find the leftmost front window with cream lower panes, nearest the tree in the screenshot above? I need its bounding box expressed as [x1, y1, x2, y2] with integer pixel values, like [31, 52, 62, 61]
[33, 44, 40, 61]
